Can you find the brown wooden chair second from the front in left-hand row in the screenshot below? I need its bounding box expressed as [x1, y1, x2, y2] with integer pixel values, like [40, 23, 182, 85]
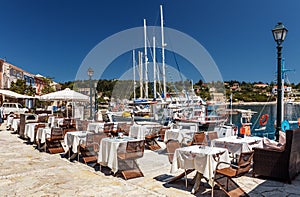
[79, 132, 107, 167]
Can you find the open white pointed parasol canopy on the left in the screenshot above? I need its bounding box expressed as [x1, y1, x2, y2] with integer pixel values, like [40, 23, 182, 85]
[40, 88, 89, 102]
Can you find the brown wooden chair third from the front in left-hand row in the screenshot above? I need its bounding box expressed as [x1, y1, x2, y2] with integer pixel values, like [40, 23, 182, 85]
[45, 127, 64, 154]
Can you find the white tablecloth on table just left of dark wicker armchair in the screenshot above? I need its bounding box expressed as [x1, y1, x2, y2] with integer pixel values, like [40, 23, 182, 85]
[211, 136, 263, 155]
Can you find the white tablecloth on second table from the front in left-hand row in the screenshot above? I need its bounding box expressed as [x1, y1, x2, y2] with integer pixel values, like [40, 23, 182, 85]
[64, 131, 90, 153]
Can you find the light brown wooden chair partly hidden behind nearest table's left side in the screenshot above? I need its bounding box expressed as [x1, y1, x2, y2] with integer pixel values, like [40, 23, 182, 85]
[166, 139, 194, 188]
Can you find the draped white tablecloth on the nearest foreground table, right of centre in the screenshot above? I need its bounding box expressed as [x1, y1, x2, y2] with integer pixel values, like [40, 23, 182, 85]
[171, 146, 230, 186]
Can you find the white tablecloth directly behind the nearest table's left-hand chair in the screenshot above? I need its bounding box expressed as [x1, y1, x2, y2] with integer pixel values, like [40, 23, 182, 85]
[164, 129, 196, 145]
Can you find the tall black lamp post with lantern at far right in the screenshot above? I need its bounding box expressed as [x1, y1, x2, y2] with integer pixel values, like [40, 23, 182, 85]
[272, 22, 288, 141]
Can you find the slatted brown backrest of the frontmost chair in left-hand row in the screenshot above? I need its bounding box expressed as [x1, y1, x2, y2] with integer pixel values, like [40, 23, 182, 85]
[126, 140, 145, 159]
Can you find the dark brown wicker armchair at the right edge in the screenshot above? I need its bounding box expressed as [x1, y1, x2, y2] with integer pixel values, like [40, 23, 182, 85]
[253, 128, 300, 183]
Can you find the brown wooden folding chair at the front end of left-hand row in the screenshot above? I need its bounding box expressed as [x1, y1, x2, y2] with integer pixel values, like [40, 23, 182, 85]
[118, 140, 145, 180]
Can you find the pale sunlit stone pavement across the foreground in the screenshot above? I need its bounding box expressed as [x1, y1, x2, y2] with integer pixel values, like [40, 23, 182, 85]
[0, 125, 300, 197]
